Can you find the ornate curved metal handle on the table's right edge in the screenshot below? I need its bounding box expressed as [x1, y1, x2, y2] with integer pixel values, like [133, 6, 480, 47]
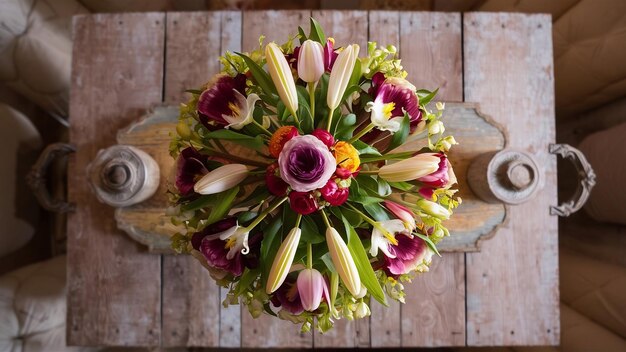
[548, 144, 596, 217]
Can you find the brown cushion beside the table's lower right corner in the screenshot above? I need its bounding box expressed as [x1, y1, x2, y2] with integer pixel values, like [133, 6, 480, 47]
[559, 249, 626, 338]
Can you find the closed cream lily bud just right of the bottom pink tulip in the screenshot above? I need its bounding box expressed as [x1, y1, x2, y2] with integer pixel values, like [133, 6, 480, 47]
[326, 227, 361, 296]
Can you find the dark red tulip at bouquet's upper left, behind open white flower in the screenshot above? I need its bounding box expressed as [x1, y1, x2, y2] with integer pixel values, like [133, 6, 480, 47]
[198, 74, 246, 130]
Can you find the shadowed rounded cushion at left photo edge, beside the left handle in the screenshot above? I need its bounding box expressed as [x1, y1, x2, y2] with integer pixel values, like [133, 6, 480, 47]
[0, 103, 42, 257]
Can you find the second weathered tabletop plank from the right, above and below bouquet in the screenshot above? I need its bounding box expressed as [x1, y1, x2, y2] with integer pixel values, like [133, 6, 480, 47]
[400, 12, 465, 346]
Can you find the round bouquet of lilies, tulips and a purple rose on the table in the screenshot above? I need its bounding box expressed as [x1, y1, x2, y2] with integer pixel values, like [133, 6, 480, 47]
[170, 19, 460, 332]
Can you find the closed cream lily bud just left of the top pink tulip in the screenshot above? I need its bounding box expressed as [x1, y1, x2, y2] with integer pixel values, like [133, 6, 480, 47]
[265, 43, 298, 120]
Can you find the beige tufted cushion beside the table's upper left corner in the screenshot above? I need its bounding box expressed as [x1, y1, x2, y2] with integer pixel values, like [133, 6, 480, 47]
[0, 0, 87, 116]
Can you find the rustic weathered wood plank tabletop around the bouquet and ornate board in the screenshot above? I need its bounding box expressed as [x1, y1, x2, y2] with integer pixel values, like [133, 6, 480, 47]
[67, 11, 560, 347]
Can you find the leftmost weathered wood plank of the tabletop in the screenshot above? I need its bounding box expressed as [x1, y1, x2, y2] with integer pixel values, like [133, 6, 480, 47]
[67, 13, 164, 346]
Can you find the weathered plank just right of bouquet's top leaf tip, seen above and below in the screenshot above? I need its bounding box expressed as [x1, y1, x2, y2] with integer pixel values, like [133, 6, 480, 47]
[304, 11, 370, 348]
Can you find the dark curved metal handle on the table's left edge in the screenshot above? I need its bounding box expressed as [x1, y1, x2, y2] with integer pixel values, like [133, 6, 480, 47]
[26, 143, 76, 213]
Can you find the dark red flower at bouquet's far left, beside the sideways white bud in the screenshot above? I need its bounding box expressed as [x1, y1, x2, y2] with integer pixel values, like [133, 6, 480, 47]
[176, 147, 209, 196]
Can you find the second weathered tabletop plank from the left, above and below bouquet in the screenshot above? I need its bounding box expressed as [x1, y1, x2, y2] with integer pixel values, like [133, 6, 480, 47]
[162, 12, 241, 347]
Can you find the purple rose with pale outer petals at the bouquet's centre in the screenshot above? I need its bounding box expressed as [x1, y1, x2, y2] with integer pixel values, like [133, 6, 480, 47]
[278, 135, 337, 192]
